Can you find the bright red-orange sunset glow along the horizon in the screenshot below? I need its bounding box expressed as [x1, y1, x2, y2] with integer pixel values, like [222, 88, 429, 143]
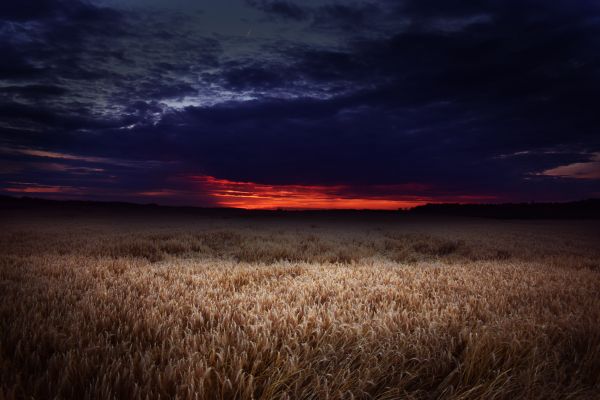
[3, 175, 496, 210]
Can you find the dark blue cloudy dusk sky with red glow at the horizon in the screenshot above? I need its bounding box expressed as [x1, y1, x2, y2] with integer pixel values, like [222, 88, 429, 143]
[0, 0, 600, 209]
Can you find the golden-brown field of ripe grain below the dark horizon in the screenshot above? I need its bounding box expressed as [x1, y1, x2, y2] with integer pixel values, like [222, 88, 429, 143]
[0, 205, 600, 399]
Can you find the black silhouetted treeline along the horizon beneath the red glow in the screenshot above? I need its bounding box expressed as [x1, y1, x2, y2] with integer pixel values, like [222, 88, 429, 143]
[0, 195, 600, 219]
